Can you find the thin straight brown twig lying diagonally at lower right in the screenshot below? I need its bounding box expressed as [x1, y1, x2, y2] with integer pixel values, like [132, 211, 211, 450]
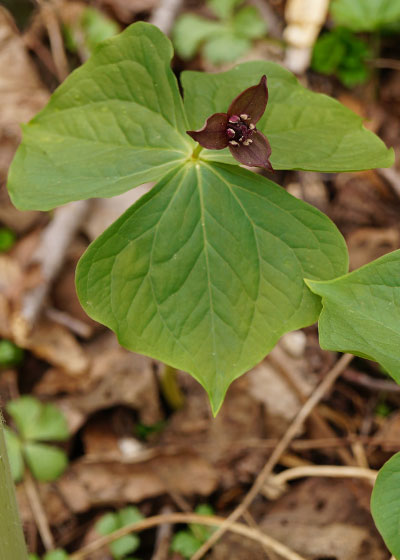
[191, 354, 353, 560]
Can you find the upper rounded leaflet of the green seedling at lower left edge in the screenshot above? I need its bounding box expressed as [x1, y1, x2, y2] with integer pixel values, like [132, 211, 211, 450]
[7, 395, 69, 441]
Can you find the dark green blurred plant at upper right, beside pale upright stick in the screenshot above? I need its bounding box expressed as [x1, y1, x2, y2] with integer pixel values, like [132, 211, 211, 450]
[311, 27, 371, 88]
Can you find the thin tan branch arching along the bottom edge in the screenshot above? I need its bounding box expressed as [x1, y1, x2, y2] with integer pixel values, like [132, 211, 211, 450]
[69, 513, 306, 560]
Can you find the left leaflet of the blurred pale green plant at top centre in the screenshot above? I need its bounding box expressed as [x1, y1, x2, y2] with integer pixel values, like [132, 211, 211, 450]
[172, 14, 225, 60]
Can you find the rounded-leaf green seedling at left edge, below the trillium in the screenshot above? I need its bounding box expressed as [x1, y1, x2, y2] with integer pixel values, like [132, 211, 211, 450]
[5, 396, 69, 482]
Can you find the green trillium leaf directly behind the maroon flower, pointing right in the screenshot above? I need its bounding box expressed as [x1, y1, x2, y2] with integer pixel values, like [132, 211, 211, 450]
[182, 61, 393, 172]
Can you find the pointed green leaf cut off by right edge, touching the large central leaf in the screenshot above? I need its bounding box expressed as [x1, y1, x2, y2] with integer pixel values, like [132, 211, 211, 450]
[307, 251, 400, 383]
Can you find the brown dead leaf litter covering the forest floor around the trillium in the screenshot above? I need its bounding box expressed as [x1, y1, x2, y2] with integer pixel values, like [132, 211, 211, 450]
[0, 0, 400, 560]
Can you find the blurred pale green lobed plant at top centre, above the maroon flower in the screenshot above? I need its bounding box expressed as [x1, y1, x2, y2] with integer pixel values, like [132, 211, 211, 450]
[173, 0, 268, 65]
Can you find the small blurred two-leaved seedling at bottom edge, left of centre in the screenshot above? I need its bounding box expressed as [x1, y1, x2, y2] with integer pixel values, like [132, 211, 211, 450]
[96, 506, 144, 560]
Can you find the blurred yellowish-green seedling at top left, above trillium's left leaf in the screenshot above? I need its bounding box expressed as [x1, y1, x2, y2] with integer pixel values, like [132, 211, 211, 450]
[63, 6, 121, 58]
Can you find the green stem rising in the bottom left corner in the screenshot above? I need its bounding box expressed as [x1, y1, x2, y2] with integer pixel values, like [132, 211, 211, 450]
[0, 412, 28, 560]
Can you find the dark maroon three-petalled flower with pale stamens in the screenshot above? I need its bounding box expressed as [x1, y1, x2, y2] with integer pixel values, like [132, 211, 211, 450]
[187, 76, 273, 171]
